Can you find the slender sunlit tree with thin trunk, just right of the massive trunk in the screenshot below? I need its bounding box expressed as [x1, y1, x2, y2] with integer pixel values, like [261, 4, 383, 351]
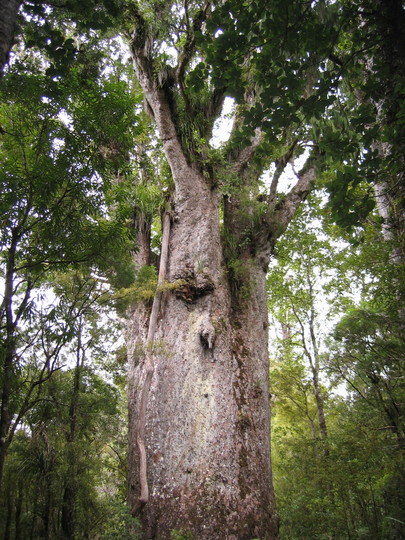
[268, 196, 350, 455]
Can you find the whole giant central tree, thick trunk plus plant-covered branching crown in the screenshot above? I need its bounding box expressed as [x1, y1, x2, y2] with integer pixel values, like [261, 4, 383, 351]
[120, 1, 338, 540]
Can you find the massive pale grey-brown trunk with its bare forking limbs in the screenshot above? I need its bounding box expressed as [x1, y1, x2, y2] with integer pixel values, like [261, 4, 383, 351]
[127, 6, 313, 540]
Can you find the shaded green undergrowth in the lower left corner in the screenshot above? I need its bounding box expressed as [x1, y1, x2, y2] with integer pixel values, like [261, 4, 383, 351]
[0, 372, 121, 539]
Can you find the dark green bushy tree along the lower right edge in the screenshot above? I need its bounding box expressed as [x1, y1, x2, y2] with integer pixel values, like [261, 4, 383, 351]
[329, 224, 405, 538]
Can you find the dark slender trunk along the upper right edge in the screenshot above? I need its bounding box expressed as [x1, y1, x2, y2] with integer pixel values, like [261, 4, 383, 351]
[364, 0, 405, 265]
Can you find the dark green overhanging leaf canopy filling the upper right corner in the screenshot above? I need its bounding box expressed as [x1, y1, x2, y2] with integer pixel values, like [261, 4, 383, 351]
[204, 0, 405, 234]
